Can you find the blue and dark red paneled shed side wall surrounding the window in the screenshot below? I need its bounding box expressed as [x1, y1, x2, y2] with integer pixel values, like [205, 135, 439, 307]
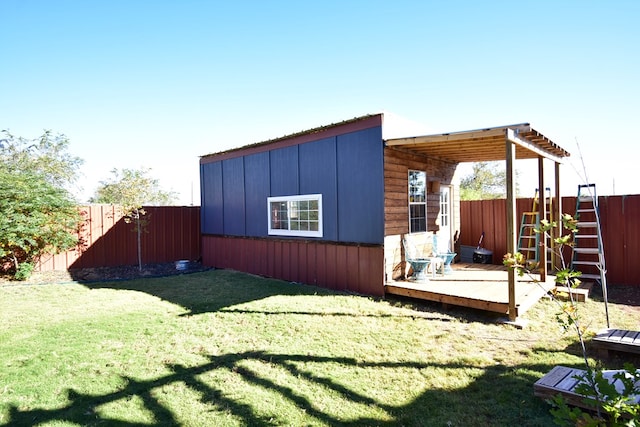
[200, 115, 384, 295]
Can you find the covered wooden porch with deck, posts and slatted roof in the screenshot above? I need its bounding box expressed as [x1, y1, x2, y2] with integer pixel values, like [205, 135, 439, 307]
[385, 123, 569, 321]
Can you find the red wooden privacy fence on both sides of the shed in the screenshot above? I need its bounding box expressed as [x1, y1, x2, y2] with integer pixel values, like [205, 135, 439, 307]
[39, 195, 640, 285]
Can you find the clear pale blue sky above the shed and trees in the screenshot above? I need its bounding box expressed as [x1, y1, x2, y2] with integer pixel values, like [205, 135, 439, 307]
[0, 0, 640, 204]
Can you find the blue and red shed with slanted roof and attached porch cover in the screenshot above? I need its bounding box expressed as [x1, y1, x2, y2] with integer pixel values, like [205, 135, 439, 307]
[200, 114, 568, 318]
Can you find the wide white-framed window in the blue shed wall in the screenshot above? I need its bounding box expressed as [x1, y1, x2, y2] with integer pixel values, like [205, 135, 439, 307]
[267, 194, 322, 237]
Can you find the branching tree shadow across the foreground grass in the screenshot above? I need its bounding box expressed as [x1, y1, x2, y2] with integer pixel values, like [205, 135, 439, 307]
[3, 351, 551, 426]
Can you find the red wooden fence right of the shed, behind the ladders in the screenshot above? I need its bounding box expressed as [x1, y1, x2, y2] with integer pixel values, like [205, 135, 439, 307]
[460, 195, 640, 285]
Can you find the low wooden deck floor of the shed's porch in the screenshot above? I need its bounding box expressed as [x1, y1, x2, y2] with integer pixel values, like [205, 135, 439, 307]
[385, 263, 555, 317]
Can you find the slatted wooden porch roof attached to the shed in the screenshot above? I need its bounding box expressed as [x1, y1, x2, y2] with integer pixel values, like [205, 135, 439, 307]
[385, 123, 570, 163]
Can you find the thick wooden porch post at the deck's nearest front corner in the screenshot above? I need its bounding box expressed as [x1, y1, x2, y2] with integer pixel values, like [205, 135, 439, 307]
[505, 129, 517, 322]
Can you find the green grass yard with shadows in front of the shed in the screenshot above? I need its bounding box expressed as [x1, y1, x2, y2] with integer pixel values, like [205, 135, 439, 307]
[0, 270, 640, 426]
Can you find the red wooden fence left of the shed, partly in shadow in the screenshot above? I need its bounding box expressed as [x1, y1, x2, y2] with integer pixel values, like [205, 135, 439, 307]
[38, 205, 201, 271]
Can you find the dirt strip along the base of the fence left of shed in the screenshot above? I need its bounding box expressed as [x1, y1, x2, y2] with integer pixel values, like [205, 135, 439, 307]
[0, 262, 209, 285]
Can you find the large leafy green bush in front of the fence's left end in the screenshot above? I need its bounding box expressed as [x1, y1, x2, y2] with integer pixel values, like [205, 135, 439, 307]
[0, 131, 81, 280]
